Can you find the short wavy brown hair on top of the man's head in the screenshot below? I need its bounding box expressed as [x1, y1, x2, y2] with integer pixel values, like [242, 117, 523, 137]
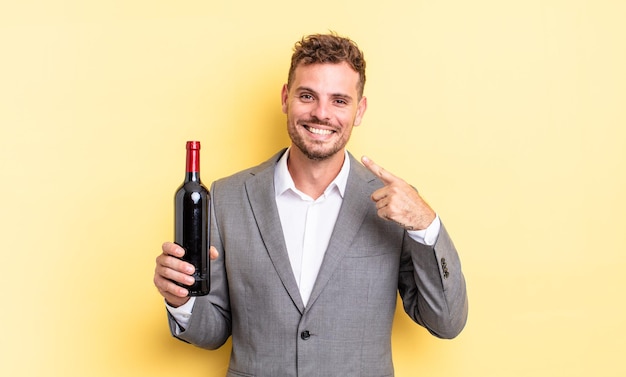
[287, 33, 365, 99]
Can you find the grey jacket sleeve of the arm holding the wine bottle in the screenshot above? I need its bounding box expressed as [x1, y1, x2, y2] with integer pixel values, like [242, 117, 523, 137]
[168, 181, 232, 349]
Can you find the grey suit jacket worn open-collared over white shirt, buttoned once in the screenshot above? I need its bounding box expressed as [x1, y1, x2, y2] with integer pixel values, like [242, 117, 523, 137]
[170, 150, 467, 377]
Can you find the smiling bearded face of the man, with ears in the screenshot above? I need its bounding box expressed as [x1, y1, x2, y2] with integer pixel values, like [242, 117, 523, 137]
[282, 62, 367, 160]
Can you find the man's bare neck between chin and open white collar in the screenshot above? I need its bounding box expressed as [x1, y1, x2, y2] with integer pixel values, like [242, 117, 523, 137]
[287, 147, 345, 199]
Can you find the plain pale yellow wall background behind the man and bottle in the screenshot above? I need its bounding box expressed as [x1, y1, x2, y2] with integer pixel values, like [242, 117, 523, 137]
[0, 0, 626, 377]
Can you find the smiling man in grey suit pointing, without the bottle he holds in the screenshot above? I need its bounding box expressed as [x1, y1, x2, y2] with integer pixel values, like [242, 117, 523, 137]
[154, 34, 467, 377]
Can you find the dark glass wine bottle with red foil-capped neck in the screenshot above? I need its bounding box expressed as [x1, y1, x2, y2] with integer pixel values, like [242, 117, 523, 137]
[174, 141, 211, 296]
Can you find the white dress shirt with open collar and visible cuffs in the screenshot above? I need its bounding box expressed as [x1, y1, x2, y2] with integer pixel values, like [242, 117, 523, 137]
[166, 149, 441, 330]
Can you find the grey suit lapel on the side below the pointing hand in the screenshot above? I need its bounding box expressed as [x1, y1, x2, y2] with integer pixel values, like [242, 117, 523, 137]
[307, 155, 375, 307]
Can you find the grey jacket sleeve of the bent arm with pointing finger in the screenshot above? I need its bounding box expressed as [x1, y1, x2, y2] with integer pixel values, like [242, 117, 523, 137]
[398, 223, 468, 339]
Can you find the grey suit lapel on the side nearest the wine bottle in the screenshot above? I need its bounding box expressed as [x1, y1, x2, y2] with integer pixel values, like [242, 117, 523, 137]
[246, 150, 304, 313]
